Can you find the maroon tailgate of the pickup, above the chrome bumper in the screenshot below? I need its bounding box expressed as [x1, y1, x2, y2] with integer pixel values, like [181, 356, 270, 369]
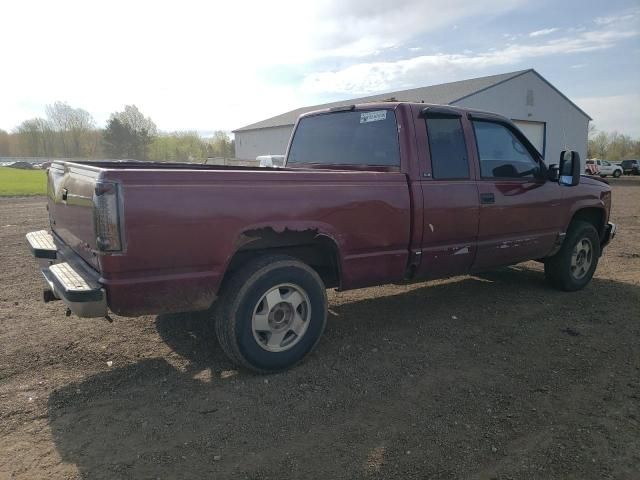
[47, 162, 100, 269]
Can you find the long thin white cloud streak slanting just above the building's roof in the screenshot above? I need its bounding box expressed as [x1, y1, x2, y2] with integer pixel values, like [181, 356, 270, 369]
[302, 19, 640, 95]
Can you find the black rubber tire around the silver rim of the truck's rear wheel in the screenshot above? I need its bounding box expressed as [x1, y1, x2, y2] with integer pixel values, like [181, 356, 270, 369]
[214, 255, 327, 373]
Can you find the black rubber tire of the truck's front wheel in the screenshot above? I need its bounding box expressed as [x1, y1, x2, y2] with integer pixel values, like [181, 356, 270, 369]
[544, 220, 600, 292]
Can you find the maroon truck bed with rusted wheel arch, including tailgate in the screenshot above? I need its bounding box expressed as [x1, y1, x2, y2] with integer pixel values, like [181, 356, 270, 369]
[49, 162, 412, 315]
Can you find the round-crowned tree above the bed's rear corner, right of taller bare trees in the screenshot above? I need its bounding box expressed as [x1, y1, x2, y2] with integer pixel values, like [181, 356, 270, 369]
[104, 105, 158, 160]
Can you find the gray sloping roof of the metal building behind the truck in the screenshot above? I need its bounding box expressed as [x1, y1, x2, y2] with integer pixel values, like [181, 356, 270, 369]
[234, 69, 532, 132]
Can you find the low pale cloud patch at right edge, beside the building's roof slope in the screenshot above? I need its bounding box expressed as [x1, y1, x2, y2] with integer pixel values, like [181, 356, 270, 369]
[575, 94, 640, 138]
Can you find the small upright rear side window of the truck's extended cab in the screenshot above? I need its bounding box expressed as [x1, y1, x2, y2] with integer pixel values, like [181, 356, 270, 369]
[426, 118, 469, 180]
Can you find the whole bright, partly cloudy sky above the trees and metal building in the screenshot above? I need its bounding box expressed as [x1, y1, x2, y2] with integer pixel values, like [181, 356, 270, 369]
[0, 0, 640, 137]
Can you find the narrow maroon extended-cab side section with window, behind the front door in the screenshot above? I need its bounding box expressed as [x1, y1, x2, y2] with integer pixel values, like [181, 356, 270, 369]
[414, 107, 479, 278]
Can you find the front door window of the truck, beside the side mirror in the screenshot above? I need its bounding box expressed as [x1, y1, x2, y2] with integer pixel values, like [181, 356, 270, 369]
[473, 120, 540, 178]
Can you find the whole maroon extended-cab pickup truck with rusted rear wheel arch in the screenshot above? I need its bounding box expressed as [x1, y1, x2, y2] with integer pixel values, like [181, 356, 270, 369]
[27, 103, 615, 371]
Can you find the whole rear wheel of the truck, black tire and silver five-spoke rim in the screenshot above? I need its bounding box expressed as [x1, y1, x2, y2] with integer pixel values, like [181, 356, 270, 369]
[215, 255, 327, 373]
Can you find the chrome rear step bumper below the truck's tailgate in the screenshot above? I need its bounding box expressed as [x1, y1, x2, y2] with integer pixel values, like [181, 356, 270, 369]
[27, 230, 107, 318]
